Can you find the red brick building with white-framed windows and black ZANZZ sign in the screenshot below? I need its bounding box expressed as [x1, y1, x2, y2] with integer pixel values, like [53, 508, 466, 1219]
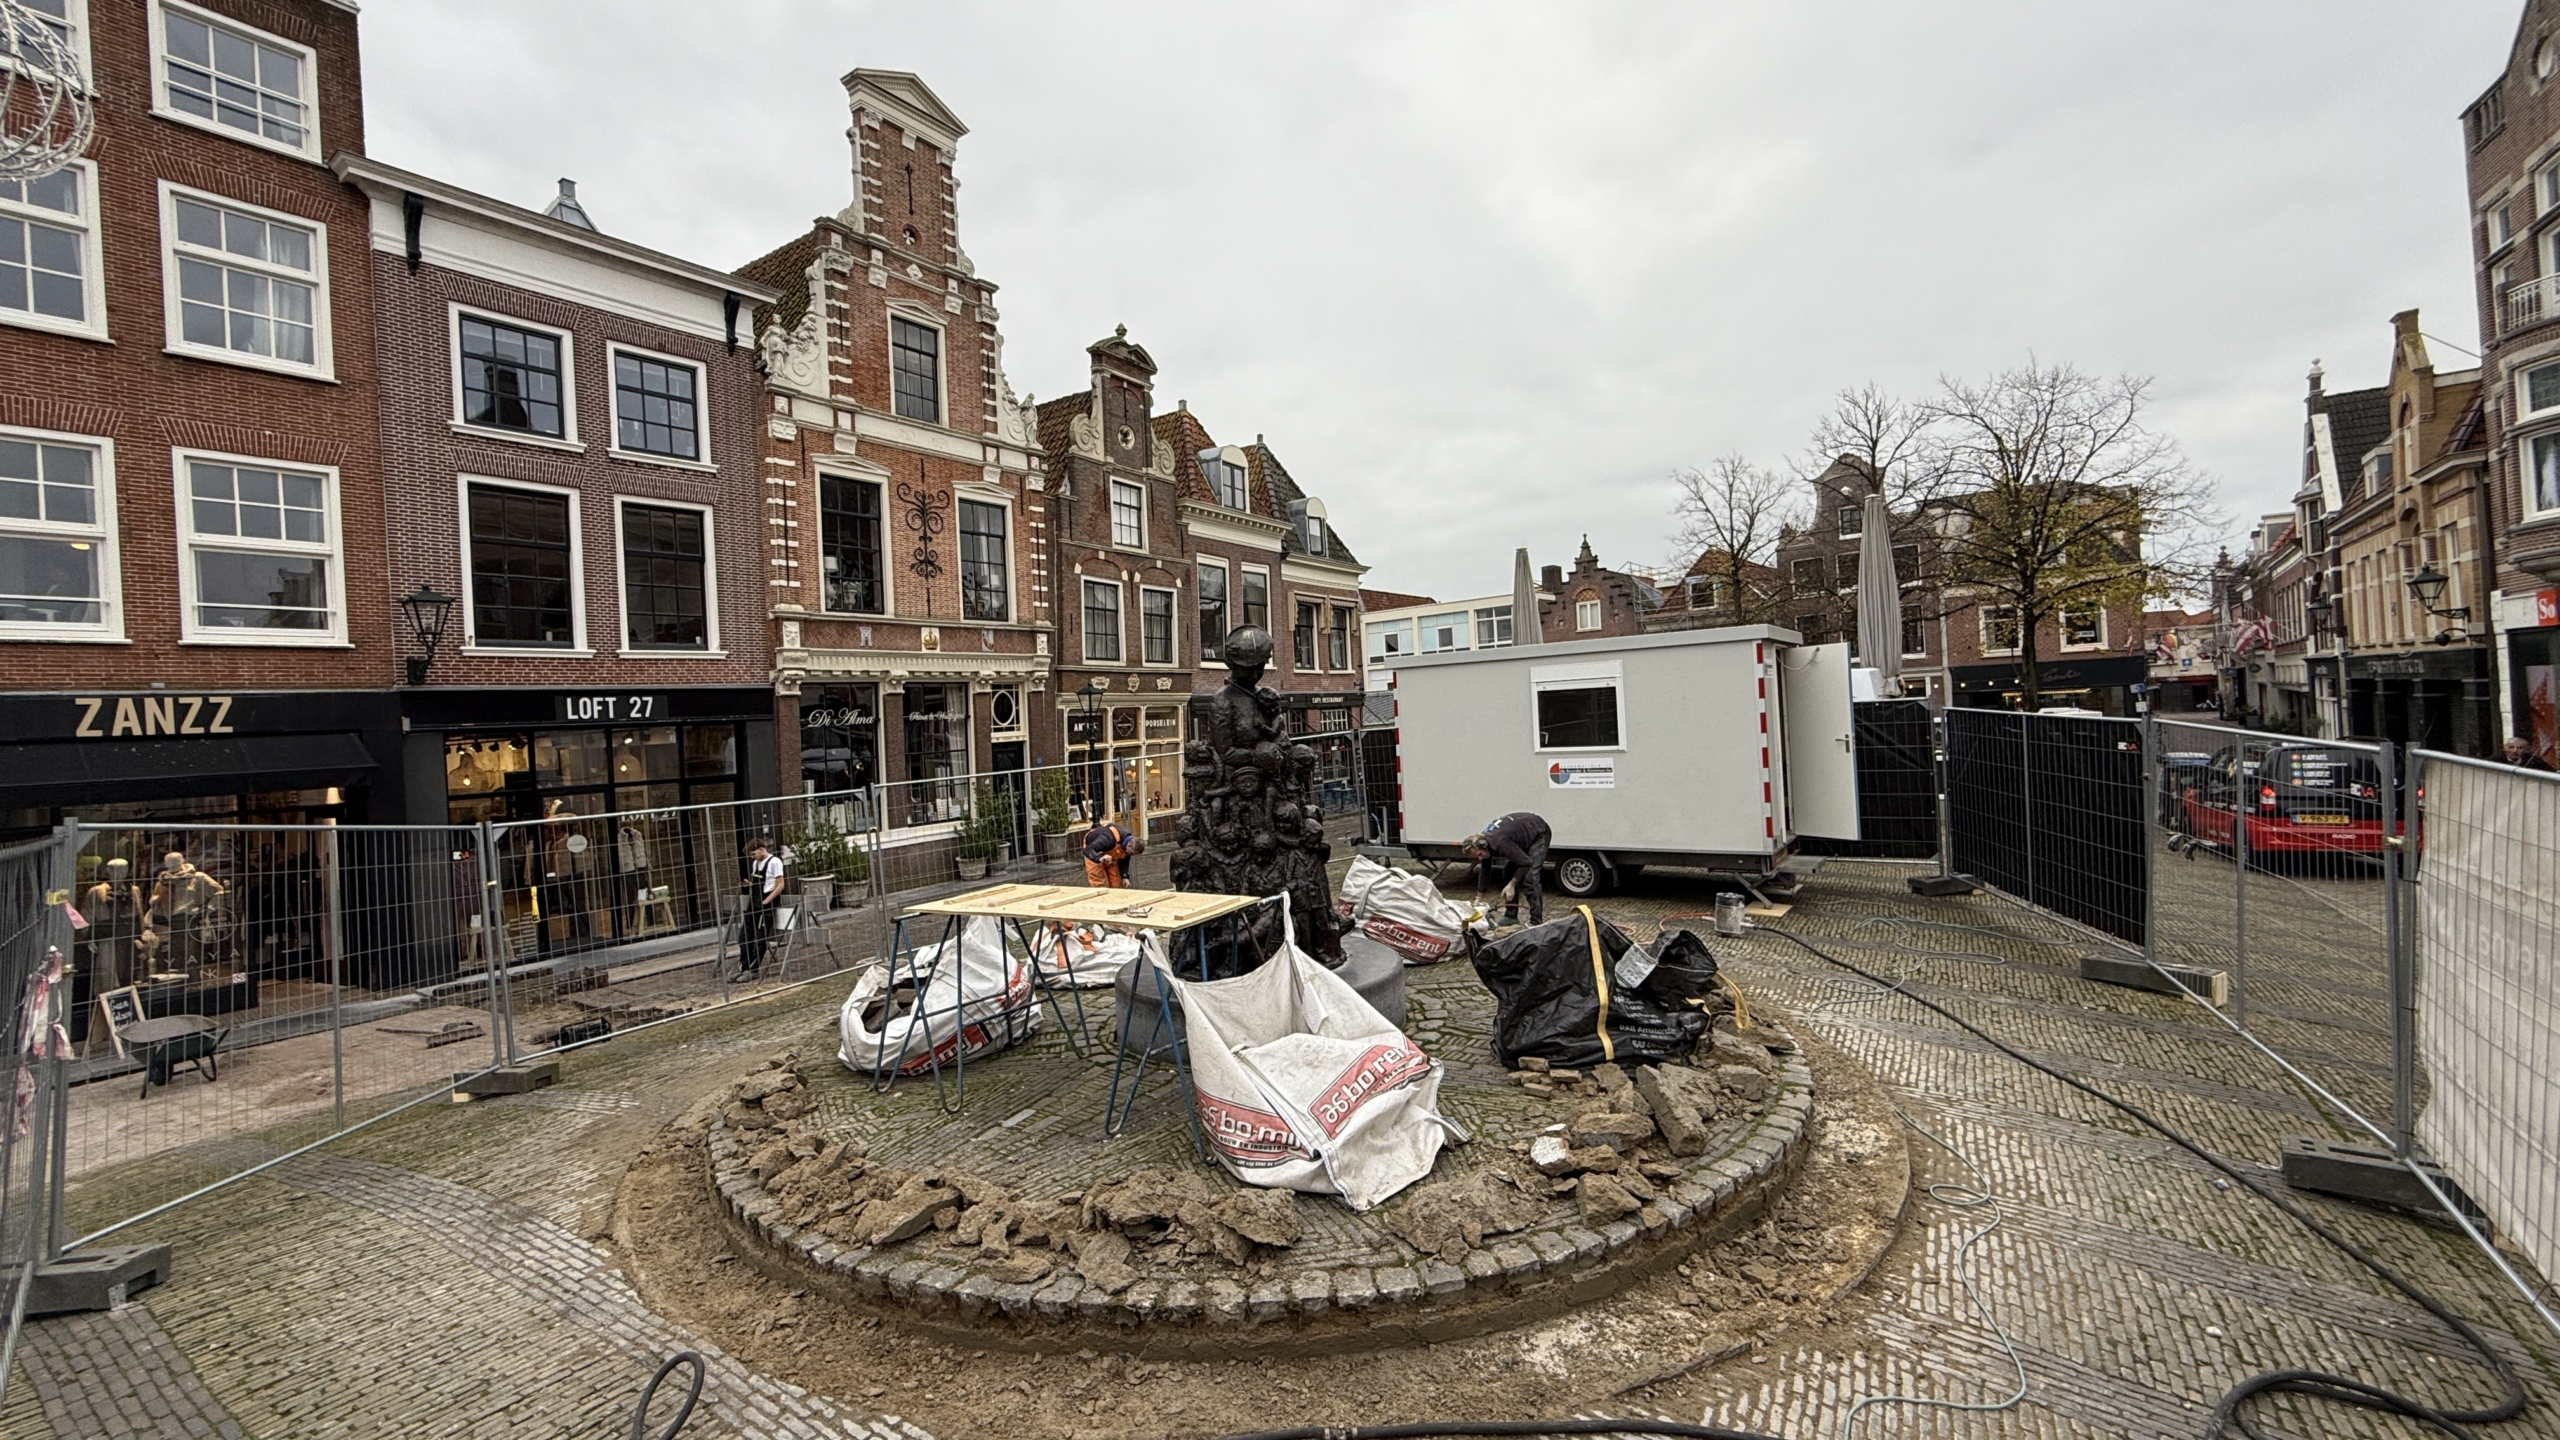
[0, 0, 407, 830]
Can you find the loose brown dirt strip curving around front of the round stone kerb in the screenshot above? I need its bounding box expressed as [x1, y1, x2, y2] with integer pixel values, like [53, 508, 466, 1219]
[612, 1014, 1910, 1440]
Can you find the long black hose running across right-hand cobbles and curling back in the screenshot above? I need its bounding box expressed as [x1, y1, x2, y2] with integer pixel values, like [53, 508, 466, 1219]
[1761, 925, 2524, 1440]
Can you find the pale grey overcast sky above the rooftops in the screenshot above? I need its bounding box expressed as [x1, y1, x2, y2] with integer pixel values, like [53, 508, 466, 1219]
[364, 0, 2522, 600]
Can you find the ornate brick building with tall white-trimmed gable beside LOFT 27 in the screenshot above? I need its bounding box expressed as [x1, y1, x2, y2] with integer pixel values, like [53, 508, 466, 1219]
[740, 69, 1054, 838]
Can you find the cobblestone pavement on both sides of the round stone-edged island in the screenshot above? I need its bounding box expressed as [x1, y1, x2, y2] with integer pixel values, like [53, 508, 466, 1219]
[0, 858, 2560, 1440]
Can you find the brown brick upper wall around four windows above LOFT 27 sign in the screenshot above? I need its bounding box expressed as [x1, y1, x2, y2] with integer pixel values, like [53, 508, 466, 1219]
[371, 249, 773, 687]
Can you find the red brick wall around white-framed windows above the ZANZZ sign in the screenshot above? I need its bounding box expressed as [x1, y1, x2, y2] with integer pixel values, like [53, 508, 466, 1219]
[0, 0, 381, 689]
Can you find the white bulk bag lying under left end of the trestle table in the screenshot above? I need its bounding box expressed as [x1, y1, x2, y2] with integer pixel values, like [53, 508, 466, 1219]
[835, 915, 1039, 1076]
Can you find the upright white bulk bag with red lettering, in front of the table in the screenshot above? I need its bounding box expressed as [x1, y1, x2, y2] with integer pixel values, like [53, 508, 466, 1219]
[1175, 899, 1467, 1209]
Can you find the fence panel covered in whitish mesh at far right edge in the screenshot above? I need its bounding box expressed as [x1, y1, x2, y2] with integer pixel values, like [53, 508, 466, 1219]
[2414, 751, 2560, 1276]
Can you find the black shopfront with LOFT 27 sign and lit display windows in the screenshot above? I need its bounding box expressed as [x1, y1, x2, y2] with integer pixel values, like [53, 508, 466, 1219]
[399, 687, 781, 958]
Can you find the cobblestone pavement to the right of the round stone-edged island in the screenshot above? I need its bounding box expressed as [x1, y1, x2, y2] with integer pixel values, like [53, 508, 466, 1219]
[1613, 856, 2560, 1437]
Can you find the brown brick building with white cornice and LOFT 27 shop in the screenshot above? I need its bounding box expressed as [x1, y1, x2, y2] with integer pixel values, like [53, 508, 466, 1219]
[335, 156, 773, 948]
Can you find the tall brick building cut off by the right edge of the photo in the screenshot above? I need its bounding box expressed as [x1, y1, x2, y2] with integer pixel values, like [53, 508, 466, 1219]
[2463, 0, 2560, 764]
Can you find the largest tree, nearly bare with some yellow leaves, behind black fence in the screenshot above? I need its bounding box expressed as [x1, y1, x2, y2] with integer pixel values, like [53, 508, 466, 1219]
[1925, 359, 2217, 710]
